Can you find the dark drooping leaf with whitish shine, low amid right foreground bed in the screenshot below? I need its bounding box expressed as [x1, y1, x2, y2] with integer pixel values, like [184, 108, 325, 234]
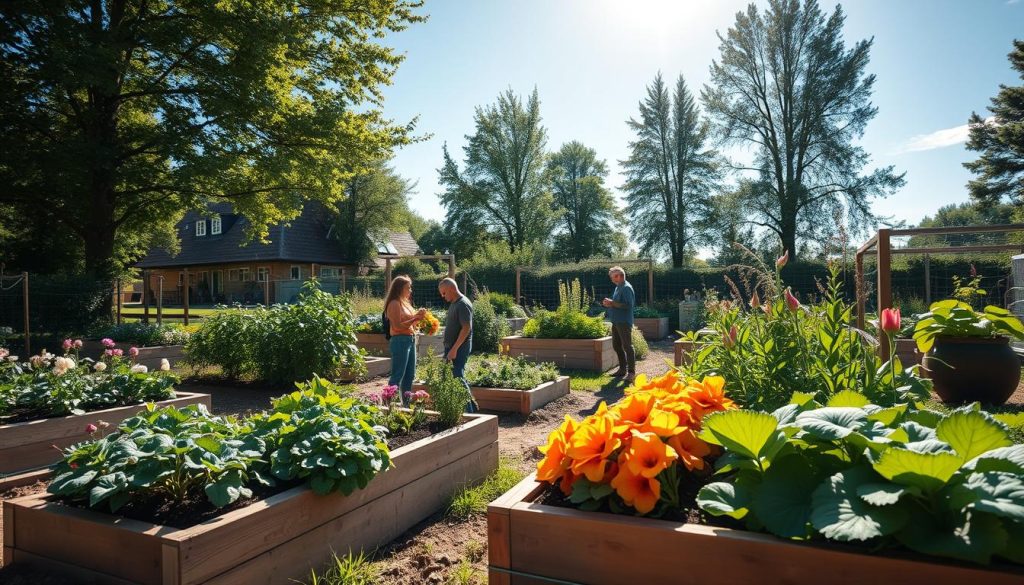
[811, 466, 908, 542]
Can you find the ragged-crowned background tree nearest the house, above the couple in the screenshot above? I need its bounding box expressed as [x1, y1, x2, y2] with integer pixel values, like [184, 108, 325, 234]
[437, 88, 554, 252]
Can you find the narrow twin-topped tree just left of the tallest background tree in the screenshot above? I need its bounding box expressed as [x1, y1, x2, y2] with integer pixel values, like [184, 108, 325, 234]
[621, 73, 722, 267]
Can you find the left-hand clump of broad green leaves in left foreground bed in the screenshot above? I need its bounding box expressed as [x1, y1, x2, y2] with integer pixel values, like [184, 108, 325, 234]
[48, 404, 272, 512]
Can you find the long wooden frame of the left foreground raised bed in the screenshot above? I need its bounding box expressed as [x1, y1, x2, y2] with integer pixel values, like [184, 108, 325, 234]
[3, 415, 498, 585]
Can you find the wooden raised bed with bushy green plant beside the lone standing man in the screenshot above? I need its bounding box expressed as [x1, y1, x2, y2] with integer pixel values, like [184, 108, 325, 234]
[501, 279, 617, 372]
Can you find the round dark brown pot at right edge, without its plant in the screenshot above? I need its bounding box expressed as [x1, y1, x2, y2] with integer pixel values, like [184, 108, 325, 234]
[923, 336, 1021, 405]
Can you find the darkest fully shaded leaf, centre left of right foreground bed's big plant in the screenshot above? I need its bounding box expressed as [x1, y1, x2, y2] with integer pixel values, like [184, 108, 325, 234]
[751, 455, 821, 538]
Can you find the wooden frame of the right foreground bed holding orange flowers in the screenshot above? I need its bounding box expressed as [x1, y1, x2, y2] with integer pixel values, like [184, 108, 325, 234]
[487, 476, 1024, 585]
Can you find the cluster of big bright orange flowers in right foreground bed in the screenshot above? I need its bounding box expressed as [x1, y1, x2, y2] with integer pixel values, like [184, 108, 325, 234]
[537, 370, 736, 514]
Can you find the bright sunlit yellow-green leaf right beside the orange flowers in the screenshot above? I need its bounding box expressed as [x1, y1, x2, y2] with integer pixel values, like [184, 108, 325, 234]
[700, 410, 785, 460]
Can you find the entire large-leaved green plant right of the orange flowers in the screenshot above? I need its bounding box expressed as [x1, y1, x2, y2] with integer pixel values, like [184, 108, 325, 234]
[697, 391, 1024, 563]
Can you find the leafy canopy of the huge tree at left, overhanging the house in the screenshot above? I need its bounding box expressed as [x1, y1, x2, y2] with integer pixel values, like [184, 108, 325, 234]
[0, 0, 423, 277]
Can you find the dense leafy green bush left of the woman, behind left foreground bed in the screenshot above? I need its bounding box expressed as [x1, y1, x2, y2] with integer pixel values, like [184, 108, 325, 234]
[186, 281, 366, 382]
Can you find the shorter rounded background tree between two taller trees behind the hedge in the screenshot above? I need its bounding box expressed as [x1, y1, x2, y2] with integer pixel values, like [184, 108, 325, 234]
[547, 140, 626, 262]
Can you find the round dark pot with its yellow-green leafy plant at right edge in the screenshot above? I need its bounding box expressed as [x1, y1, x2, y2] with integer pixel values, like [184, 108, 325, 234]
[913, 299, 1024, 405]
